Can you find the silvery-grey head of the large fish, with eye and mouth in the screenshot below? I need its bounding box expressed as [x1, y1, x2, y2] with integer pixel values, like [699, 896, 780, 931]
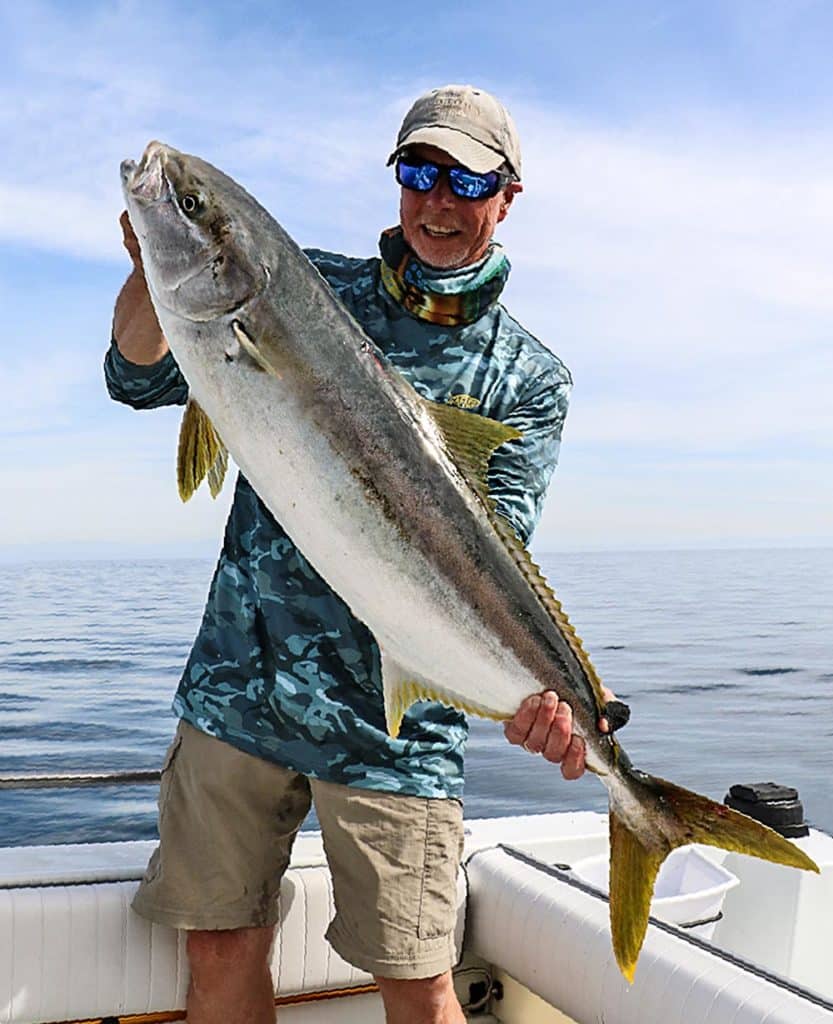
[121, 142, 269, 322]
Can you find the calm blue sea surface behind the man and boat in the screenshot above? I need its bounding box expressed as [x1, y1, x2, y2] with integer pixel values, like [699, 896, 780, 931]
[0, 549, 833, 846]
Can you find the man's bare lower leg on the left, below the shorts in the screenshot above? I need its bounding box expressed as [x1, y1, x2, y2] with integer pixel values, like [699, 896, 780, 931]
[186, 928, 274, 1024]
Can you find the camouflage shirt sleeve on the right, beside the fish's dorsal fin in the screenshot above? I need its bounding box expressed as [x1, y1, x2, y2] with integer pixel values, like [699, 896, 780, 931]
[489, 370, 573, 544]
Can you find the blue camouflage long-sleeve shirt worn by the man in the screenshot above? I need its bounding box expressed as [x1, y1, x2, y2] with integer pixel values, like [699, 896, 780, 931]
[105, 250, 572, 799]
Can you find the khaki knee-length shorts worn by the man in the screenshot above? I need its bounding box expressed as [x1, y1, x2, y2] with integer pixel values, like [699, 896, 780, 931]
[133, 721, 463, 978]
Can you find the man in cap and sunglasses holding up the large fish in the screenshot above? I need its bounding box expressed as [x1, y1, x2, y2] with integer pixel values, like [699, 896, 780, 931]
[106, 86, 607, 1024]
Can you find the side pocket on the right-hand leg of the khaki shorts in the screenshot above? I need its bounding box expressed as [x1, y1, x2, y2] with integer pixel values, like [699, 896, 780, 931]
[417, 800, 463, 939]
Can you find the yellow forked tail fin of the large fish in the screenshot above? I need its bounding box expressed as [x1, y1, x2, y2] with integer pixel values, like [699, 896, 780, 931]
[610, 769, 819, 981]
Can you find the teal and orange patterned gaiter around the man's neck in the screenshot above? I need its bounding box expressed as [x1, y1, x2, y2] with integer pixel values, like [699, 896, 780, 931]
[379, 227, 509, 327]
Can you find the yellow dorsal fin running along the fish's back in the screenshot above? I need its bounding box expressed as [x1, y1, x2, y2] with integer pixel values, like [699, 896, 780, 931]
[425, 401, 605, 712]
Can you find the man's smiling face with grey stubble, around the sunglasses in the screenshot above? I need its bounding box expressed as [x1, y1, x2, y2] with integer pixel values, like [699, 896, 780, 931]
[400, 144, 522, 270]
